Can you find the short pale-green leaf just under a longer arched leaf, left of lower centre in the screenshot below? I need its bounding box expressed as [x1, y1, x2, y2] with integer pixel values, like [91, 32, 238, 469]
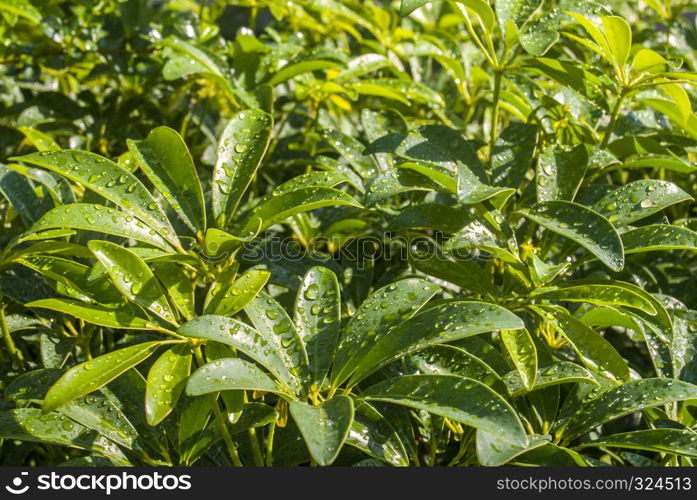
[186, 358, 287, 396]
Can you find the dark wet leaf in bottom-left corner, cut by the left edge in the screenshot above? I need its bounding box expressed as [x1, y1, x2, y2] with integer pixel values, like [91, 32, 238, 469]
[0, 408, 128, 465]
